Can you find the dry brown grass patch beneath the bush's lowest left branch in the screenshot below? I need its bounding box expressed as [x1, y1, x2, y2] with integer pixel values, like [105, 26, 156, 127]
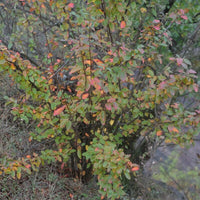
[0, 167, 98, 200]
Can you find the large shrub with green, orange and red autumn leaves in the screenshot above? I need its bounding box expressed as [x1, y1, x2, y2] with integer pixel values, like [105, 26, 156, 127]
[0, 0, 200, 199]
